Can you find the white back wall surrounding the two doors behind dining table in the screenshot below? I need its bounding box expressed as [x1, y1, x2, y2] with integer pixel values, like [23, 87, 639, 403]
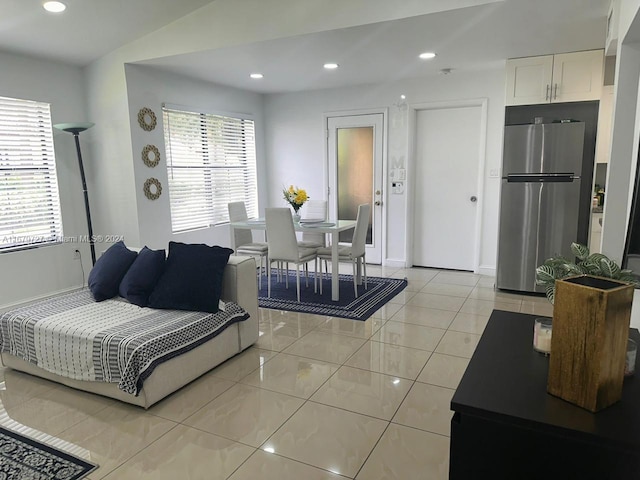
[265, 69, 505, 273]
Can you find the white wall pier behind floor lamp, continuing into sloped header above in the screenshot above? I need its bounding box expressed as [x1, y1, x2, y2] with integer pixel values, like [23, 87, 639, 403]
[86, 0, 497, 255]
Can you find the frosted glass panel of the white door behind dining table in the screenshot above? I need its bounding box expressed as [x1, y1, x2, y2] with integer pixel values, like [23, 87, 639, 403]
[337, 127, 373, 245]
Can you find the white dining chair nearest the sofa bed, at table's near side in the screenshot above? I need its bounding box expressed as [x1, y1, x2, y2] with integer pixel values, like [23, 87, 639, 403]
[265, 208, 318, 302]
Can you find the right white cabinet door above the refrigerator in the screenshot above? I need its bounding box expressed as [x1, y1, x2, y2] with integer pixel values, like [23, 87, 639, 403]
[551, 50, 604, 102]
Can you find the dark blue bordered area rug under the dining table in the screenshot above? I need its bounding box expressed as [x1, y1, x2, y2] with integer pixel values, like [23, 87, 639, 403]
[258, 270, 407, 320]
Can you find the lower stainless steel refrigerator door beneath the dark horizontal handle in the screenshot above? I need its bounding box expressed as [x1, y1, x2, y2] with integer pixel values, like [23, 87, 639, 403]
[496, 179, 580, 292]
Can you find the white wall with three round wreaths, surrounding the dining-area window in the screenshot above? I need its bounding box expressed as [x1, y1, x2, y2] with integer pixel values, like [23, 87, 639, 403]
[126, 65, 266, 248]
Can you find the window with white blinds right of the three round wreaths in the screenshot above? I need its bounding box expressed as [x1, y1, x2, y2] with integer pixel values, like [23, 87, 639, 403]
[162, 105, 258, 233]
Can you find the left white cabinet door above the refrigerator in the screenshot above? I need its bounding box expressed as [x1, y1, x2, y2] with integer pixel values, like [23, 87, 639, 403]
[505, 55, 553, 105]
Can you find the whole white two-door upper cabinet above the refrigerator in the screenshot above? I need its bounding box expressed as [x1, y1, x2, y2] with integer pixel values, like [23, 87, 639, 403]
[506, 50, 604, 105]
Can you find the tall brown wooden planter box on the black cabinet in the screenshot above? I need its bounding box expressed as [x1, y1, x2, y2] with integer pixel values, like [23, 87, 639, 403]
[547, 275, 634, 412]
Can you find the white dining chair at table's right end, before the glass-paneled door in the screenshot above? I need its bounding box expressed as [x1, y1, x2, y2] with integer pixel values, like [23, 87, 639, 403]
[317, 203, 371, 298]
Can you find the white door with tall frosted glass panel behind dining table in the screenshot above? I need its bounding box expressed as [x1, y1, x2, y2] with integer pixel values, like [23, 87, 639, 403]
[327, 113, 384, 264]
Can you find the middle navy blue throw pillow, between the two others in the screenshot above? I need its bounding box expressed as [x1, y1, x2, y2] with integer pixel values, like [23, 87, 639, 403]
[118, 247, 166, 307]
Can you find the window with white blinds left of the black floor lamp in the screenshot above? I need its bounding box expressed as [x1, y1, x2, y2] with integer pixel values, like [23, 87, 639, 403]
[0, 97, 62, 251]
